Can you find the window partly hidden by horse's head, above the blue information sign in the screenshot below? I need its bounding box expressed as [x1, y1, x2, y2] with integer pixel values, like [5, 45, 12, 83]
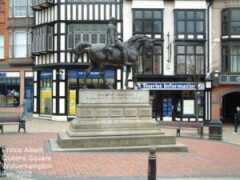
[138, 44, 163, 74]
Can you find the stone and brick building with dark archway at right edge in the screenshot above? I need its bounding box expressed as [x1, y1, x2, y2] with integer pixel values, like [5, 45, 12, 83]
[210, 0, 240, 123]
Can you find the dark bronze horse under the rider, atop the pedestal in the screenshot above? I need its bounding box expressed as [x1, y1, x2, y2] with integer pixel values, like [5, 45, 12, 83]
[72, 35, 155, 88]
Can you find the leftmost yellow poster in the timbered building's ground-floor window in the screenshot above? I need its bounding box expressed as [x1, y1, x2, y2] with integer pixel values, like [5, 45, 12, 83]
[40, 88, 52, 114]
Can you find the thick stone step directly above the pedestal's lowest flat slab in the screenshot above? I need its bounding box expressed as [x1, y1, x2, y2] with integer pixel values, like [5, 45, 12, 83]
[57, 133, 176, 148]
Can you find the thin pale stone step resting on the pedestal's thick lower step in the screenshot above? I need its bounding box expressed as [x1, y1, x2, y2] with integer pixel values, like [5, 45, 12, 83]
[66, 129, 164, 137]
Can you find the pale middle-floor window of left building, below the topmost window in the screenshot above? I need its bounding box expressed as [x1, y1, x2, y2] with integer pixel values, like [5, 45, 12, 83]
[9, 31, 31, 58]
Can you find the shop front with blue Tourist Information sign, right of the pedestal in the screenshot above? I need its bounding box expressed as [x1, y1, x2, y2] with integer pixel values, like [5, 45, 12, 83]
[137, 82, 209, 122]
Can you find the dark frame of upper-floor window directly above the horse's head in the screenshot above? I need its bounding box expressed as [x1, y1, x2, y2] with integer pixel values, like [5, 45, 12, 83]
[132, 8, 164, 39]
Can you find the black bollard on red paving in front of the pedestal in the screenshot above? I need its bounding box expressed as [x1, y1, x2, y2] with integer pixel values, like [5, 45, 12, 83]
[148, 148, 156, 180]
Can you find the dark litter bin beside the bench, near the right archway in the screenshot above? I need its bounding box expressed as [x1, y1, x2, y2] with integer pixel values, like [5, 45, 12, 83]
[208, 120, 223, 140]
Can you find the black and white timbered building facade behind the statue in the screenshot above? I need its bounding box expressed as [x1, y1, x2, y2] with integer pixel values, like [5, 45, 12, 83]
[32, 0, 211, 121]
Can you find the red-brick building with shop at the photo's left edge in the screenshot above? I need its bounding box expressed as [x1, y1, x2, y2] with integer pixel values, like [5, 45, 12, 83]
[0, 0, 33, 112]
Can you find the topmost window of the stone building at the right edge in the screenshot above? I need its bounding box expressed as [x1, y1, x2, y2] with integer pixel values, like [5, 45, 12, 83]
[222, 8, 240, 35]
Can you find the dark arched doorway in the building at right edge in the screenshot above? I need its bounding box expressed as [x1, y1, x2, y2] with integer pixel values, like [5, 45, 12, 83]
[222, 92, 240, 124]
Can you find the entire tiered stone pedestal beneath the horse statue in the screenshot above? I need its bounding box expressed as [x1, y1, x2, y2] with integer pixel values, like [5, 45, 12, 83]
[50, 90, 187, 152]
